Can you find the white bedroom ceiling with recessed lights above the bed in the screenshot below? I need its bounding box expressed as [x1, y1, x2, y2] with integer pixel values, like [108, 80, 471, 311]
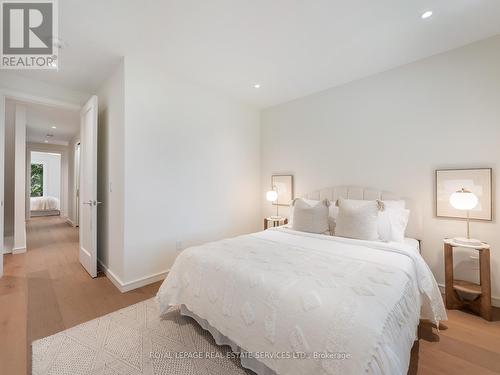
[12, 0, 500, 108]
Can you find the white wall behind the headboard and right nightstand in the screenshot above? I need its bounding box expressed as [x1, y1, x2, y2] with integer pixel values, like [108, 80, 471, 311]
[261, 37, 500, 304]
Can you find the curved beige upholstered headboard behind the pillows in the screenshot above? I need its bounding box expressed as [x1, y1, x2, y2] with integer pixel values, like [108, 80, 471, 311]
[302, 186, 423, 239]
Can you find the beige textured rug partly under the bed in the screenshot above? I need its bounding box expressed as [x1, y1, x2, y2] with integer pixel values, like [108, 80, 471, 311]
[32, 299, 253, 375]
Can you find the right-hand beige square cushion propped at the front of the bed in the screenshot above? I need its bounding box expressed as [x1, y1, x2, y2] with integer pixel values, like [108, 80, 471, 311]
[335, 199, 381, 241]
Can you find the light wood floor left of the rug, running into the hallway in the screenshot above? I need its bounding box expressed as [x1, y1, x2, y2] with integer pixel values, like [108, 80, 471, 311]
[0, 217, 160, 375]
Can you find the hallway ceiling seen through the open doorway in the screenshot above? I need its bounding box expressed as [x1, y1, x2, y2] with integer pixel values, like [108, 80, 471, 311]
[7, 100, 80, 146]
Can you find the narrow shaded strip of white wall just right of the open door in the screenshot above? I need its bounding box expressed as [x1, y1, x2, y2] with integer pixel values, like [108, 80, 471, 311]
[97, 62, 125, 281]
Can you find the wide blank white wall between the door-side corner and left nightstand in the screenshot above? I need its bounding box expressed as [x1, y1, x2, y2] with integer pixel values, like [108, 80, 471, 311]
[124, 55, 260, 282]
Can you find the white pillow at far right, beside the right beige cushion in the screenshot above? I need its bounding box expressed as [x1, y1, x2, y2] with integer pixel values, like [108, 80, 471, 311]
[378, 201, 410, 242]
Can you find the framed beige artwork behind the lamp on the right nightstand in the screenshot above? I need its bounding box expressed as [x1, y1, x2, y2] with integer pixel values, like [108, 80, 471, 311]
[435, 168, 493, 221]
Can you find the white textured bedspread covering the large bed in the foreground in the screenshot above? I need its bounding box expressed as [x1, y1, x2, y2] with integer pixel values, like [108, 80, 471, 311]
[158, 228, 446, 374]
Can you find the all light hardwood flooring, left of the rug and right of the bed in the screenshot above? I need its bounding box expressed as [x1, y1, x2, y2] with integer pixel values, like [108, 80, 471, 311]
[0, 217, 500, 375]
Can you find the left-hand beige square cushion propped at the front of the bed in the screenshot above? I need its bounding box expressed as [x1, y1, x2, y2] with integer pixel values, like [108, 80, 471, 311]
[292, 198, 330, 234]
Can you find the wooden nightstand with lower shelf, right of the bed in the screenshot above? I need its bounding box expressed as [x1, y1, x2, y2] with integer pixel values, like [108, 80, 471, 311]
[444, 239, 491, 320]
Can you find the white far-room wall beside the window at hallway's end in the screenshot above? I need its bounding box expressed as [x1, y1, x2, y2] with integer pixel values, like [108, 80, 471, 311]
[31, 151, 62, 200]
